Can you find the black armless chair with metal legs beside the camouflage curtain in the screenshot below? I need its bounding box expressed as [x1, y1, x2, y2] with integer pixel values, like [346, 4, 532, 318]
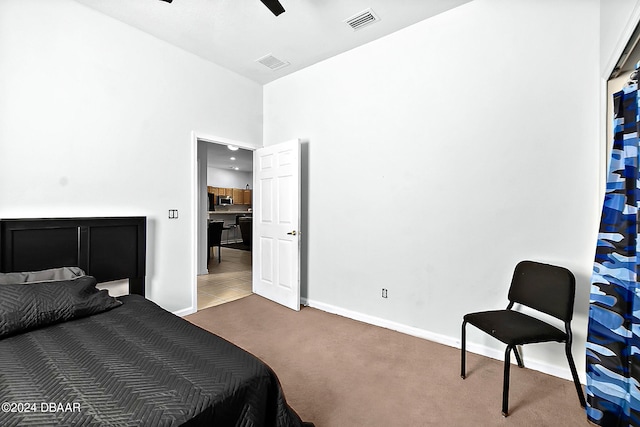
[460, 261, 586, 417]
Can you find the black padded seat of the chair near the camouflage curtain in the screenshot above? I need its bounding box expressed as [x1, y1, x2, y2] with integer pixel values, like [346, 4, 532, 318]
[464, 310, 567, 345]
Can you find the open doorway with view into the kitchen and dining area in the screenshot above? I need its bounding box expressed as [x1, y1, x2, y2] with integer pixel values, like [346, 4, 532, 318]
[195, 138, 253, 310]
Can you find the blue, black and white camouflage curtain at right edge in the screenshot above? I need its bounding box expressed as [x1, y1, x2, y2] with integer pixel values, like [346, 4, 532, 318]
[587, 84, 640, 426]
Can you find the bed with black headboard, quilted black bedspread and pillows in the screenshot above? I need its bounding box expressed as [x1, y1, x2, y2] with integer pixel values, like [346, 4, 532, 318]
[0, 217, 312, 427]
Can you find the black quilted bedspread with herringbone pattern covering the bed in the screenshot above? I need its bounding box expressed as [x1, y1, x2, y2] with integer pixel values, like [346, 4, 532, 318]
[0, 295, 302, 427]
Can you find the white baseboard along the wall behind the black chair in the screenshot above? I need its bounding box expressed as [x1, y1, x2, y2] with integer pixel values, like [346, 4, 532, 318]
[301, 298, 586, 384]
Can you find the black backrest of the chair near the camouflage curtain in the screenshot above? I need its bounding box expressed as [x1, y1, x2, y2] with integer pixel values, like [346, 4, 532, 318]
[509, 261, 576, 322]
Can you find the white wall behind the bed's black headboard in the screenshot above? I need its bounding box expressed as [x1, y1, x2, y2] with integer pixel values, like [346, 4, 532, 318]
[0, 0, 262, 311]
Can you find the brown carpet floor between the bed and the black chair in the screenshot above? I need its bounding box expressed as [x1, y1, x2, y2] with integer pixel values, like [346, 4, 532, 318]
[186, 295, 592, 427]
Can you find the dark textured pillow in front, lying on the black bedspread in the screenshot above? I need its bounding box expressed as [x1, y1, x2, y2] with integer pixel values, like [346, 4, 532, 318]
[0, 276, 122, 338]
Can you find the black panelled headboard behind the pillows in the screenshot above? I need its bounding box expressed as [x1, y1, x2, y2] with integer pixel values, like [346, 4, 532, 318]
[0, 217, 147, 296]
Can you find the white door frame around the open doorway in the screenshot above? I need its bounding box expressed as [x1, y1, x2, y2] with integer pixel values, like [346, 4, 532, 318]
[190, 131, 260, 315]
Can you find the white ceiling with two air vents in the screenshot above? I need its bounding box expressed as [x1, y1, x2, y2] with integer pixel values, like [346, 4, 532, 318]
[75, 0, 471, 84]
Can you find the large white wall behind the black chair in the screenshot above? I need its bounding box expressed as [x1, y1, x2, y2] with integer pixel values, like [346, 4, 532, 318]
[264, 0, 602, 378]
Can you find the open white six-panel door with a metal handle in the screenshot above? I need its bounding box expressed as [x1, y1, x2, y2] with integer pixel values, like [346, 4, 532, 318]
[252, 139, 300, 311]
